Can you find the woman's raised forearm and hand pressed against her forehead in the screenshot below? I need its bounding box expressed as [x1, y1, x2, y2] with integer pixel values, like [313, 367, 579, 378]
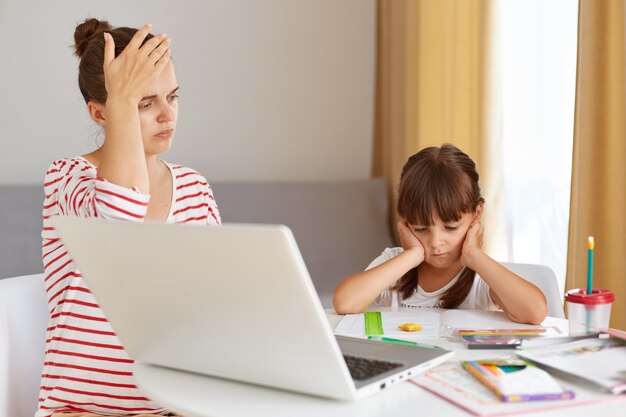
[98, 25, 170, 194]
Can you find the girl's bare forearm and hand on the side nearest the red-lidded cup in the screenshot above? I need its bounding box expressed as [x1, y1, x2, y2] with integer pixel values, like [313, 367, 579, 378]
[461, 223, 548, 324]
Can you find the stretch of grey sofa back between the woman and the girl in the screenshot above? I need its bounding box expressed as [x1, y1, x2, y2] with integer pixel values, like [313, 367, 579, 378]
[213, 179, 392, 307]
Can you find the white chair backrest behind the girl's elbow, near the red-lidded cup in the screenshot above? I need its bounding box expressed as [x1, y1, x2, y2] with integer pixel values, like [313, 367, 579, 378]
[502, 262, 565, 318]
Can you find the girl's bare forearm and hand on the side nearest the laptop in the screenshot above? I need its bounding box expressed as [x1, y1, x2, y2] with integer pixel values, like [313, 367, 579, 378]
[333, 221, 424, 314]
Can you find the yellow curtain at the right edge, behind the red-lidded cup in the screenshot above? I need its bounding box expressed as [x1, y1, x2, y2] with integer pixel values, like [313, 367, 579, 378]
[566, 0, 626, 329]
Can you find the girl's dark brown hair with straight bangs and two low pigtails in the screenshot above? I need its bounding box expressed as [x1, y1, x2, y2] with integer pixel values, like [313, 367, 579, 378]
[393, 144, 485, 308]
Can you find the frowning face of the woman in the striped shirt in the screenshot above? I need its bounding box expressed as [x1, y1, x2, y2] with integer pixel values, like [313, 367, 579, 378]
[139, 61, 178, 155]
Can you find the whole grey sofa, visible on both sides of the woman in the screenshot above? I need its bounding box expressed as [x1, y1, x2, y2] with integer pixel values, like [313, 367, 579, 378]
[0, 179, 392, 307]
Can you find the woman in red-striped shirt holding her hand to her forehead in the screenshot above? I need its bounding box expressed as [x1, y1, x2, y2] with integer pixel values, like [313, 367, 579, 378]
[37, 19, 220, 417]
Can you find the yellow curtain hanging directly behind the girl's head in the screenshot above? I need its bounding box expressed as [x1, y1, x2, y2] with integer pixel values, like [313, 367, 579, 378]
[373, 0, 506, 257]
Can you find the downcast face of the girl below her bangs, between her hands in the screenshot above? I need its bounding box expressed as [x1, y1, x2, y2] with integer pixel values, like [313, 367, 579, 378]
[411, 211, 480, 268]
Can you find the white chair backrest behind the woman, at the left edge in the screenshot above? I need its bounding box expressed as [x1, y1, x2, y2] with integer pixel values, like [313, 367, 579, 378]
[0, 274, 48, 417]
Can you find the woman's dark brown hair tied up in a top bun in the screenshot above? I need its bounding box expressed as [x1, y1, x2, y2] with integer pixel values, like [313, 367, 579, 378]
[74, 18, 154, 104]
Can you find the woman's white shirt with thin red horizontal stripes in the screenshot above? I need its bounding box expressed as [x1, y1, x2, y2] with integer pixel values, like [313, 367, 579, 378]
[36, 157, 220, 417]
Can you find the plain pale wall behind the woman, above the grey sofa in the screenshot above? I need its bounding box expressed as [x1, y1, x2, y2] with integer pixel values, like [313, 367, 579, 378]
[0, 0, 376, 184]
